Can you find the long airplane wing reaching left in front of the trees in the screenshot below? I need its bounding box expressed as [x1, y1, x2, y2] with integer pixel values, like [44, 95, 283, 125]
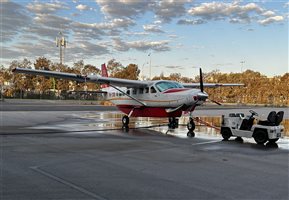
[12, 67, 149, 88]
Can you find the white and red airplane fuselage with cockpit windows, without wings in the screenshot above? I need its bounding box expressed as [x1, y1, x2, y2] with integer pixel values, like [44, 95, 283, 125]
[108, 81, 208, 117]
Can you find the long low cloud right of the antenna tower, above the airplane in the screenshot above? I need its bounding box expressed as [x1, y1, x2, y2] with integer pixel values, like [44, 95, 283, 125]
[113, 38, 170, 51]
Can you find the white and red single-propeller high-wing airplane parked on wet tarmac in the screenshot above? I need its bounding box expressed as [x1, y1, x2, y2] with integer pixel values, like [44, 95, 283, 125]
[12, 64, 244, 137]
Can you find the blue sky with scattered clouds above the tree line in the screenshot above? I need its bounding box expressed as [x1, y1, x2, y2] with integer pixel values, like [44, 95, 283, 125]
[0, 0, 289, 77]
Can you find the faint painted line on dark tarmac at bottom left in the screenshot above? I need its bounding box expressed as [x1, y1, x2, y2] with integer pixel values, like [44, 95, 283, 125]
[30, 166, 106, 200]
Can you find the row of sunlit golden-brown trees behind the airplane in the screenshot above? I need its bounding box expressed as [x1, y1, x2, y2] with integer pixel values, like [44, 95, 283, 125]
[0, 57, 289, 106]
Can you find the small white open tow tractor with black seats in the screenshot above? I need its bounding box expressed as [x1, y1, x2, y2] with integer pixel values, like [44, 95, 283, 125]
[221, 110, 284, 144]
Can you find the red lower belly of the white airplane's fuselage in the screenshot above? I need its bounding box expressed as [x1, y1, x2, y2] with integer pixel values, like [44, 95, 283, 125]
[117, 105, 182, 117]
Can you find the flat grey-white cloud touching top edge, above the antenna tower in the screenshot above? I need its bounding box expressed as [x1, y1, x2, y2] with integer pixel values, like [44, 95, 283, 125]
[27, 1, 69, 14]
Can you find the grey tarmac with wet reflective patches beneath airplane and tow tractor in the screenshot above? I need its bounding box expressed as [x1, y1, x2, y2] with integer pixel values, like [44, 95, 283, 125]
[0, 103, 289, 199]
